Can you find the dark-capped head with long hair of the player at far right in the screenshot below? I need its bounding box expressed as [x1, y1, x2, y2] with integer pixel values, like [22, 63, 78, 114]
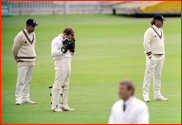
[150, 14, 166, 28]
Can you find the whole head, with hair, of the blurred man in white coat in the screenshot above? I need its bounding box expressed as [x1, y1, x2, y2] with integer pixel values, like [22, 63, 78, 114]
[118, 80, 135, 101]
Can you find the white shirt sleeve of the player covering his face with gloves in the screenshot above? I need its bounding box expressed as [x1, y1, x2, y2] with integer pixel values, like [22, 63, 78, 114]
[51, 39, 63, 57]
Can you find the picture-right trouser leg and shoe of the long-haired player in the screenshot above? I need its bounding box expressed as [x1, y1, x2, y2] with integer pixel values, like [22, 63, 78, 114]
[153, 55, 167, 101]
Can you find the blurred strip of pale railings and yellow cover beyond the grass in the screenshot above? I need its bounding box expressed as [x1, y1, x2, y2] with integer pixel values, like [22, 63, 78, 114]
[1, 1, 181, 16]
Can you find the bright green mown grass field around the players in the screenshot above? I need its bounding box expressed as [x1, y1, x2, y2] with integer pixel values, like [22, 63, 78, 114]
[1, 15, 181, 124]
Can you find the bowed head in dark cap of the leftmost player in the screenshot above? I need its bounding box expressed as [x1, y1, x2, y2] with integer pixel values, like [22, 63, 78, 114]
[26, 19, 38, 33]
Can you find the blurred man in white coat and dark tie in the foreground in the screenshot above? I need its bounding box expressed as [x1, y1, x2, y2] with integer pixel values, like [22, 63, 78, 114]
[108, 80, 149, 124]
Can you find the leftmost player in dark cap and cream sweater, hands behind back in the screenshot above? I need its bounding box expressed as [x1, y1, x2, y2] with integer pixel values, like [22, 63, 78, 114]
[12, 19, 38, 105]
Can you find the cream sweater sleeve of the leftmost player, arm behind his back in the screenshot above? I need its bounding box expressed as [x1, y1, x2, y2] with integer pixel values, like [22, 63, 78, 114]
[12, 33, 22, 60]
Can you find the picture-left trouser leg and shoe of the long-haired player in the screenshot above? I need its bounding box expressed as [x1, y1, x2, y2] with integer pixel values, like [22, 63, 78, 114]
[142, 56, 156, 102]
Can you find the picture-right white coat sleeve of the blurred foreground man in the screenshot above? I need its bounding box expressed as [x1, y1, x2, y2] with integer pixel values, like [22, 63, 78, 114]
[136, 104, 149, 124]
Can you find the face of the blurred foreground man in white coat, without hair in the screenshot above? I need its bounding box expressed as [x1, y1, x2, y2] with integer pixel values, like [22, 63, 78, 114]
[119, 85, 131, 101]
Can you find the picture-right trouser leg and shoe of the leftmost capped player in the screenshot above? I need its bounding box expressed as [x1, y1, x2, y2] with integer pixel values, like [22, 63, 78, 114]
[22, 66, 36, 104]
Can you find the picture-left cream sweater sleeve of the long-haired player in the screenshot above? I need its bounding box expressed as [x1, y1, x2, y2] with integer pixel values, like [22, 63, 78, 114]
[143, 29, 152, 53]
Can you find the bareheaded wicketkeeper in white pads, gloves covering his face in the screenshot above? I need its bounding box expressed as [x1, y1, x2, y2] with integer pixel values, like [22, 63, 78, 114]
[51, 28, 75, 112]
